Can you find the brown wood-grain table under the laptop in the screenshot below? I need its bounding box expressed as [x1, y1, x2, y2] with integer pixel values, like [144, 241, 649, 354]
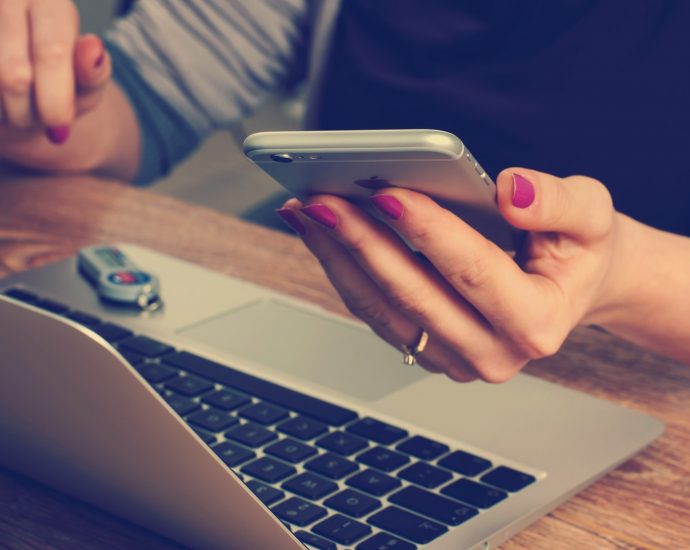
[0, 176, 690, 550]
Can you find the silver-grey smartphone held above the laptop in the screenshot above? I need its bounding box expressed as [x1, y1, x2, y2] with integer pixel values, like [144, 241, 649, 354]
[244, 130, 520, 251]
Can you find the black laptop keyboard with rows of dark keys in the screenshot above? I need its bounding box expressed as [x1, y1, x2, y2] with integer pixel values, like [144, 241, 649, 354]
[5, 288, 536, 550]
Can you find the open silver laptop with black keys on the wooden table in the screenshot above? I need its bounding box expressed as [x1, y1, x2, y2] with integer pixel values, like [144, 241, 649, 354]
[0, 244, 663, 550]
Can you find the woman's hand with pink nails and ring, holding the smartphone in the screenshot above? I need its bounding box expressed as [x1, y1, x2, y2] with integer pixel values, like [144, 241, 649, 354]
[279, 168, 622, 382]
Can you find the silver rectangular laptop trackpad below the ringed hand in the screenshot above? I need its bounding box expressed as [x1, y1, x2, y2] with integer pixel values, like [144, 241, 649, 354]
[178, 299, 426, 401]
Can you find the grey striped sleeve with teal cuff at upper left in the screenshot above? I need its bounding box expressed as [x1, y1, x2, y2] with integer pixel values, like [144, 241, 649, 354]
[106, 0, 308, 181]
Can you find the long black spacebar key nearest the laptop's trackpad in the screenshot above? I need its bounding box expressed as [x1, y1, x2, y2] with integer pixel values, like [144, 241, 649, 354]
[162, 351, 357, 426]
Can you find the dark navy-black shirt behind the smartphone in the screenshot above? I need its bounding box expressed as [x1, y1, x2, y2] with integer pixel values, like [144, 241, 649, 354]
[318, 0, 690, 235]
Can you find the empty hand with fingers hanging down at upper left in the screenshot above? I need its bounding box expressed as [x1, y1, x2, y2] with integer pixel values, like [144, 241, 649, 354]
[0, 0, 111, 147]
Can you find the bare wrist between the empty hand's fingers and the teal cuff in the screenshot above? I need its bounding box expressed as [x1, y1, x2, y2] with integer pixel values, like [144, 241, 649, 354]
[0, 82, 141, 180]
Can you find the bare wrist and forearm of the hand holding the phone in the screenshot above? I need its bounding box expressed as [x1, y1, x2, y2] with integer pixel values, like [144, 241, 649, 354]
[598, 214, 690, 364]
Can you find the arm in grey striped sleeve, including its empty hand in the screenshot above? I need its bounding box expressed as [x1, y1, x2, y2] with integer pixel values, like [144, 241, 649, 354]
[0, 0, 306, 183]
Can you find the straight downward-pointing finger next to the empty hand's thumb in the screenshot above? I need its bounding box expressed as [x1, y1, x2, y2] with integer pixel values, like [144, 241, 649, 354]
[29, 0, 79, 127]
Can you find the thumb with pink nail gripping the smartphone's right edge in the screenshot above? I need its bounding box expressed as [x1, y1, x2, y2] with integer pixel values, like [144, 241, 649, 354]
[497, 168, 615, 241]
